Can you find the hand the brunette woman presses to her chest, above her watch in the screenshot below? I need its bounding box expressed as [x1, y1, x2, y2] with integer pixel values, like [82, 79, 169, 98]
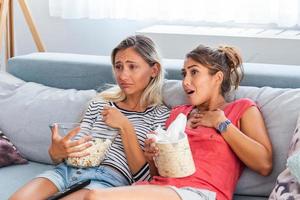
[188, 109, 227, 128]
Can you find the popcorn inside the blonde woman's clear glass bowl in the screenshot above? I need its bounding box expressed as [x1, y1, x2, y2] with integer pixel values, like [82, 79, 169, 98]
[66, 138, 112, 168]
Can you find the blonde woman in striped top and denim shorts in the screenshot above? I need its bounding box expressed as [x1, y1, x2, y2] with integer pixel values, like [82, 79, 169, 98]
[10, 35, 169, 200]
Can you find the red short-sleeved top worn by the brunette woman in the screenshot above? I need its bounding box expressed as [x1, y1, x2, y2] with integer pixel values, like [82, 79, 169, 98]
[145, 99, 256, 200]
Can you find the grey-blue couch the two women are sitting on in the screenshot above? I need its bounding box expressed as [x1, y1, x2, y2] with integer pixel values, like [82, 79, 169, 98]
[0, 53, 300, 200]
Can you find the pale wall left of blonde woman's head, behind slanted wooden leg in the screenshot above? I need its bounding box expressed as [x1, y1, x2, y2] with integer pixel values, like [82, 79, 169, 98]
[1, 0, 153, 70]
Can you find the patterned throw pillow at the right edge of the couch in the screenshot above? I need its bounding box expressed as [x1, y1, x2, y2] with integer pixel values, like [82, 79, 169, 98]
[269, 115, 300, 200]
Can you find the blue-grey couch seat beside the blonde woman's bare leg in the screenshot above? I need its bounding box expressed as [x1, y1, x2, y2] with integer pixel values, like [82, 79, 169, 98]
[0, 162, 53, 199]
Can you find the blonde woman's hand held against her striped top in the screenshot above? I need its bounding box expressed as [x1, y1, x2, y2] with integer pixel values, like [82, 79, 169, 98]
[101, 106, 130, 129]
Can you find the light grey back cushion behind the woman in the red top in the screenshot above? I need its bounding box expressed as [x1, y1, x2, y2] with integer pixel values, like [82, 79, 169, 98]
[163, 81, 300, 196]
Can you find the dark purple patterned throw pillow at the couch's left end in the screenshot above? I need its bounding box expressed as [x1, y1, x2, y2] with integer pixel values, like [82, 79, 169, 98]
[0, 131, 27, 167]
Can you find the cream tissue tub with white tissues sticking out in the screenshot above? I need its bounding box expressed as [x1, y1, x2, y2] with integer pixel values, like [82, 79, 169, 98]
[154, 114, 196, 178]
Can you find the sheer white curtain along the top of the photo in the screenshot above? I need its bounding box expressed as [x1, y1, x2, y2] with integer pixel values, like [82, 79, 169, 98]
[49, 0, 300, 27]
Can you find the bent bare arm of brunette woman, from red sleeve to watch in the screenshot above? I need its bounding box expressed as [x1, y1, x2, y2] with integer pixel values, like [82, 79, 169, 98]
[222, 106, 272, 176]
